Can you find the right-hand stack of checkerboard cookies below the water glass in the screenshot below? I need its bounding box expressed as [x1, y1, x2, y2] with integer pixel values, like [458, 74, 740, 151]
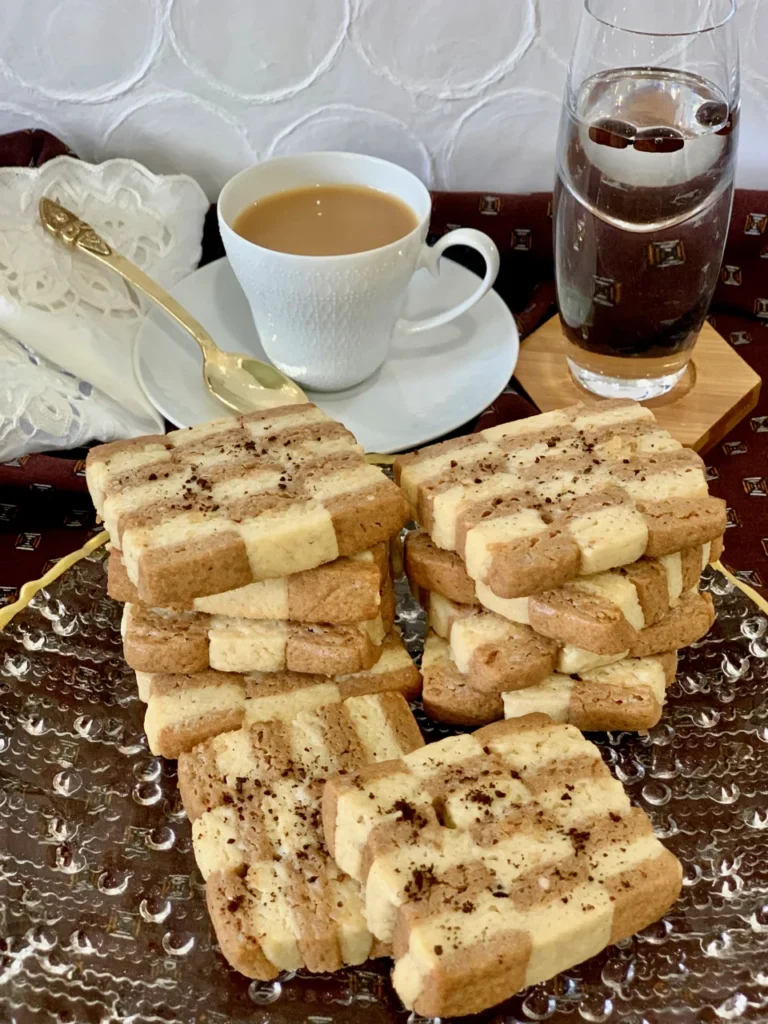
[395, 401, 725, 730]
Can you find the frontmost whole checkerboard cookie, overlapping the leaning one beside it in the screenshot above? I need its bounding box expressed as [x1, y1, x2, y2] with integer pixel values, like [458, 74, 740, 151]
[323, 715, 682, 1017]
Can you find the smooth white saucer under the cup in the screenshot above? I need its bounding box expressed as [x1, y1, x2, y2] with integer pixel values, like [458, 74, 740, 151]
[134, 259, 519, 453]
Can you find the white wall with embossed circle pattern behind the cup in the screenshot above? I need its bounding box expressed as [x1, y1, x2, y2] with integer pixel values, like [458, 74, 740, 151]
[0, 0, 768, 197]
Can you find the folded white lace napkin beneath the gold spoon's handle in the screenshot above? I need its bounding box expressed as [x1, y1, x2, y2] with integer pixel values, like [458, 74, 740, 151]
[0, 157, 208, 462]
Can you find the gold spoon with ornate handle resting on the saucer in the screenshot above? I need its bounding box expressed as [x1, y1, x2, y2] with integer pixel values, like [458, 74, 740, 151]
[40, 198, 309, 413]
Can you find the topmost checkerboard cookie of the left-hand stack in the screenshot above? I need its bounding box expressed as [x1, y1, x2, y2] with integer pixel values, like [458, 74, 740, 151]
[86, 404, 409, 607]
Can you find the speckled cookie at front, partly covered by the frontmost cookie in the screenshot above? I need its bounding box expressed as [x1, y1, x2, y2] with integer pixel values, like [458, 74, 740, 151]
[178, 693, 423, 980]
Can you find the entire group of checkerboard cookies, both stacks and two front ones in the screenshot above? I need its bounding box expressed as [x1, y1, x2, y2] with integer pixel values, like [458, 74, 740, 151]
[82, 403, 724, 1017]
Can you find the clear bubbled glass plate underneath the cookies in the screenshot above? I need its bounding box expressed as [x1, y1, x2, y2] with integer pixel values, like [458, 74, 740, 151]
[0, 551, 768, 1024]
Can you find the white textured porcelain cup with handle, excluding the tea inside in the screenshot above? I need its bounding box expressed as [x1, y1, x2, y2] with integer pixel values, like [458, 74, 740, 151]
[218, 153, 499, 391]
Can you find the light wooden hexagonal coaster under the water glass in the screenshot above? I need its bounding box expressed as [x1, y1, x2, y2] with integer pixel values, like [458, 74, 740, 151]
[515, 316, 762, 452]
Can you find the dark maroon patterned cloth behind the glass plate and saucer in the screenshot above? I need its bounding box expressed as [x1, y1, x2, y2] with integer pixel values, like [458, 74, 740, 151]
[0, 130, 768, 604]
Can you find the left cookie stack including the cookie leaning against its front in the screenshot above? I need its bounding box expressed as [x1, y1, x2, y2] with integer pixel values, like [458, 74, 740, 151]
[86, 404, 434, 978]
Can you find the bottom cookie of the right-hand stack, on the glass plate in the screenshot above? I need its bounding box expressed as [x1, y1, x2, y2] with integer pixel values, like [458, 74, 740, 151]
[422, 633, 677, 732]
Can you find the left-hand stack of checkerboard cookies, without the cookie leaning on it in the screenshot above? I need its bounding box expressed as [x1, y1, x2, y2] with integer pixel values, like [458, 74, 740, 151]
[87, 404, 420, 757]
